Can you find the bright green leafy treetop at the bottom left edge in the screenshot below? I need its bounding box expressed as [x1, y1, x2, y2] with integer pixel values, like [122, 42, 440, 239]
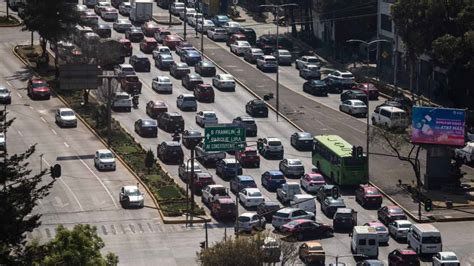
[27, 224, 119, 265]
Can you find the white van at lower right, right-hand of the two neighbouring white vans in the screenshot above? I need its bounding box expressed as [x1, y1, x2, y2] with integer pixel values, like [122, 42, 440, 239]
[407, 224, 443, 255]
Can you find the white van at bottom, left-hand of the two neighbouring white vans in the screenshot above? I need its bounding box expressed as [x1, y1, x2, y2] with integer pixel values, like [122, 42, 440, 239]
[351, 226, 379, 258]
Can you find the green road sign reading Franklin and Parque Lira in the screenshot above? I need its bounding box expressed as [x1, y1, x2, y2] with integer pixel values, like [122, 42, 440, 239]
[204, 124, 245, 151]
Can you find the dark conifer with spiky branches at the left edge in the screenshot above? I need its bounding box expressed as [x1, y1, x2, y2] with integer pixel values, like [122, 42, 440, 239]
[0, 114, 55, 265]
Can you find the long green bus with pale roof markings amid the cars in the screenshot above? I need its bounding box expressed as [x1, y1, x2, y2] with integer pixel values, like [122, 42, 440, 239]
[313, 135, 369, 186]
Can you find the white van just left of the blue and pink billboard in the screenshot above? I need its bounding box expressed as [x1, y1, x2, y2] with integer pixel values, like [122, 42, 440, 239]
[372, 106, 409, 130]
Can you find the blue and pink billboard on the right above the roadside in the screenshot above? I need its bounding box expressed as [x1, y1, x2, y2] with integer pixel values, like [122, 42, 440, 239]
[411, 106, 465, 146]
